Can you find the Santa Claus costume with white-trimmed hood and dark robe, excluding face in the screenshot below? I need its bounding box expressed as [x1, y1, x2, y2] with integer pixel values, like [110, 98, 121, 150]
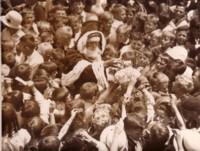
[61, 21, 108, 95]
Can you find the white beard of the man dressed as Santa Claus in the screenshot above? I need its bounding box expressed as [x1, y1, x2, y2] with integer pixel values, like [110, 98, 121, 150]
[83, 47, 101, 62]
